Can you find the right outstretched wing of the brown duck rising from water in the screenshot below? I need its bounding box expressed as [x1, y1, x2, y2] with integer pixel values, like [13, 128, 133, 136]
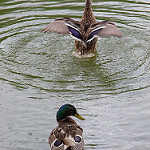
[87, 21, 122, 42]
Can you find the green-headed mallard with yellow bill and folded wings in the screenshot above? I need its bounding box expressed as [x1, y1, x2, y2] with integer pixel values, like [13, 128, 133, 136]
[49, 104, 84, 150]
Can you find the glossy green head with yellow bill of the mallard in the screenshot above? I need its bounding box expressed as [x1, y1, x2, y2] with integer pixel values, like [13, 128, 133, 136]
[56, 104, 85, 121]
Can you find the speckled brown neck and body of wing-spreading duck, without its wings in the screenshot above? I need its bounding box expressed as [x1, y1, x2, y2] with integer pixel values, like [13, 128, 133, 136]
[73, 0, 98, 57]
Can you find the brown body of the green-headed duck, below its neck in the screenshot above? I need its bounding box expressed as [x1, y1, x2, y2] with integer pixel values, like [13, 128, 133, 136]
[49, 124, 84, 150]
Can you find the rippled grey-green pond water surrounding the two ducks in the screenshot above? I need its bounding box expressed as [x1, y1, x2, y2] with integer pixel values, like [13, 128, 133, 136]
[0, 0, 150, 150]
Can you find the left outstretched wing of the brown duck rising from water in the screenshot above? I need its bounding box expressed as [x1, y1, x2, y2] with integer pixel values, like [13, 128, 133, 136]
[43, 17, 82, 41]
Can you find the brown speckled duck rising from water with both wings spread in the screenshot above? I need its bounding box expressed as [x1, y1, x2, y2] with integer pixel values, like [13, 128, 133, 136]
[43, 0, 122, 57]
